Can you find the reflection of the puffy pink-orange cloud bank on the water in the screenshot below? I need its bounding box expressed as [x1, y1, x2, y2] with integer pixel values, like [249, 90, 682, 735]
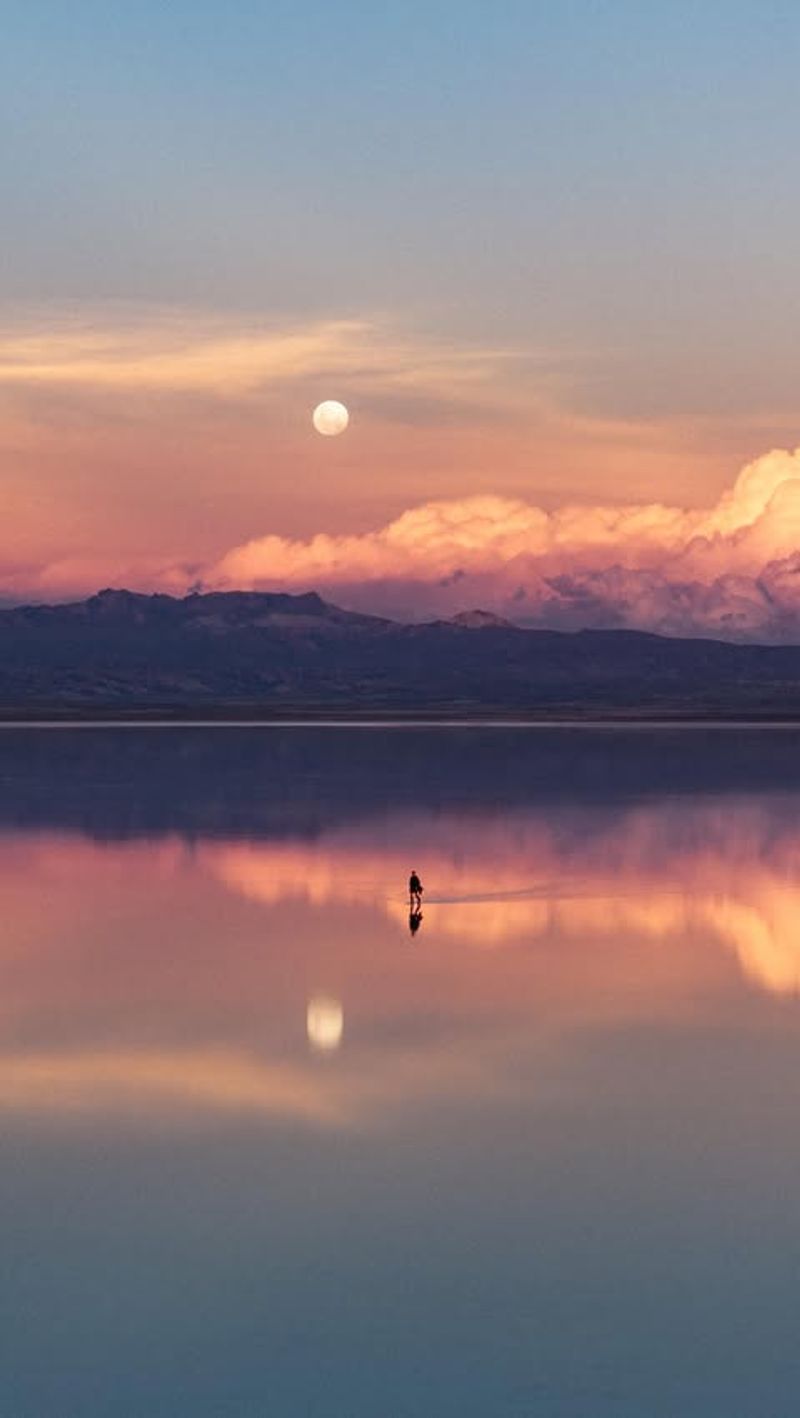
[203, 798, 800, 993]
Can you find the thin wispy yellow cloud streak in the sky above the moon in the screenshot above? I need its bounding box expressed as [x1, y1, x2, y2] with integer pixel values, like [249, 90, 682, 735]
[0, 306, 519, 404]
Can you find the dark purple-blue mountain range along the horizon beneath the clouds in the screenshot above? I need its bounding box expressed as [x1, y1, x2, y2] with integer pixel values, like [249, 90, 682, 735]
[0, 590, 800, 719]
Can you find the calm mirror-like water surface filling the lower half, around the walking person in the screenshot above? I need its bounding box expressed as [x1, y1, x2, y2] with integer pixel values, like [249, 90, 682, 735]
[0, 729, 800, 1418]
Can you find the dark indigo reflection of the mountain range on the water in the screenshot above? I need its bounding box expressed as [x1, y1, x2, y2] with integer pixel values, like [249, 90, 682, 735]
[0, 726, 800, 839]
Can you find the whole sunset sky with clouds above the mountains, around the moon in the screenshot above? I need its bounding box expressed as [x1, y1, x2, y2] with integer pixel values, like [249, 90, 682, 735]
[0, 0, 800, 640]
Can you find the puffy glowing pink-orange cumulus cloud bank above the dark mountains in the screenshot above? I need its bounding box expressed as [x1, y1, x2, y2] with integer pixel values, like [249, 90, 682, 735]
[204, 448, 800, 641]
